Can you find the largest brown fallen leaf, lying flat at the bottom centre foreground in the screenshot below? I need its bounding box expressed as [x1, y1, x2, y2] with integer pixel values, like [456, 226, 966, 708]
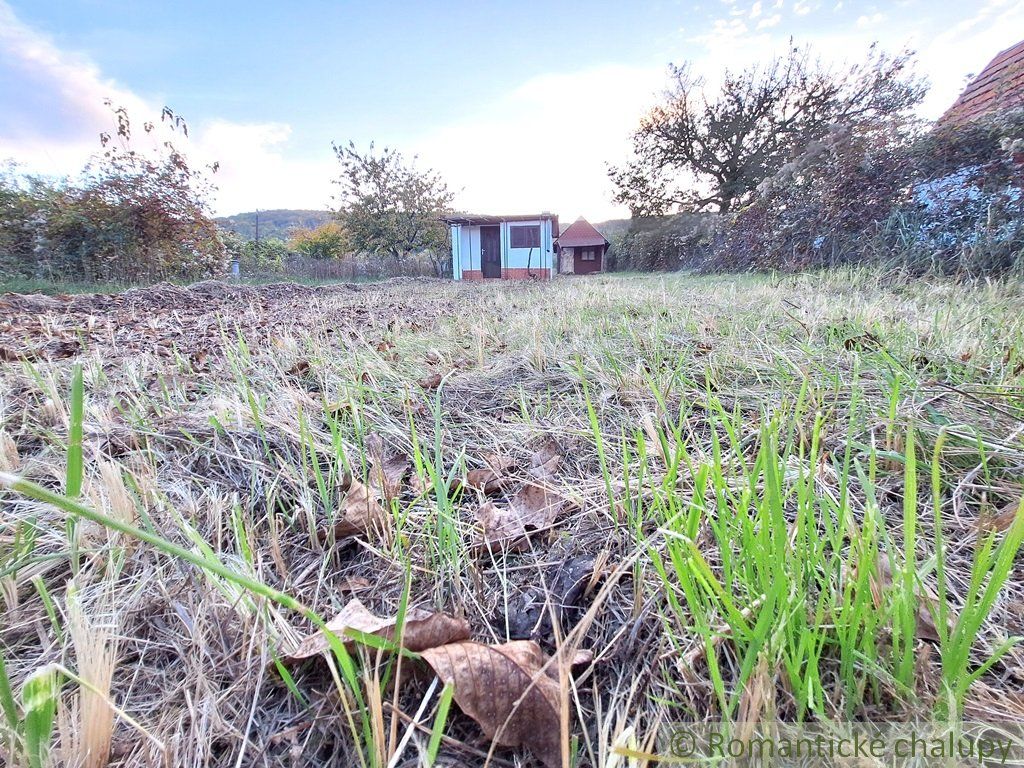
[423, 640, 577, 768]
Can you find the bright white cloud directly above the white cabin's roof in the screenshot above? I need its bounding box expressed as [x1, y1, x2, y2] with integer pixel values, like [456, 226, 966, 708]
[415, 66, 666, 221]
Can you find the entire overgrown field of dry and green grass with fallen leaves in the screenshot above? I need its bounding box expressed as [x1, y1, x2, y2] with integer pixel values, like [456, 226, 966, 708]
[0, 271, 1024, 768]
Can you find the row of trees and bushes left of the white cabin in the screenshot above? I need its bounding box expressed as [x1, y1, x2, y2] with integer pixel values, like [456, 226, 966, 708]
[0, 103, 454, 283]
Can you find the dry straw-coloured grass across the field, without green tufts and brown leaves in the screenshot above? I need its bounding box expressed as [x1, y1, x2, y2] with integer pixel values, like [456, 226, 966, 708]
[0, 272, 1024, 766]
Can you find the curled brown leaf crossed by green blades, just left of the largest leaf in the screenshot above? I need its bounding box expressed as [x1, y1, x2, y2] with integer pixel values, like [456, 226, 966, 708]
[285, 597, 470, 662]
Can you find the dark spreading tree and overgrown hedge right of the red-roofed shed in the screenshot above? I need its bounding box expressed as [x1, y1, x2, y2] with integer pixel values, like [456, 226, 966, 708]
[608, 43, 1024, 274]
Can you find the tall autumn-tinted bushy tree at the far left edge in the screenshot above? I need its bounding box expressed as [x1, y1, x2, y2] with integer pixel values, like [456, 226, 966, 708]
[0, 102, 225, 281]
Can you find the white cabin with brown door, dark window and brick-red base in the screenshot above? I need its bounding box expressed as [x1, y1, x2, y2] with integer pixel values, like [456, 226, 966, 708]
[443, 213, 558, 280]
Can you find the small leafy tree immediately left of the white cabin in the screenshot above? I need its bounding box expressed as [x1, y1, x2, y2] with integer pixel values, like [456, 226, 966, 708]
[334, 141, 455, 274]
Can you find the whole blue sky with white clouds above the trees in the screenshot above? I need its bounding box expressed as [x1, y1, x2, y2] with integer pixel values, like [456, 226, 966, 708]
[0, 0, 1024, 221]
